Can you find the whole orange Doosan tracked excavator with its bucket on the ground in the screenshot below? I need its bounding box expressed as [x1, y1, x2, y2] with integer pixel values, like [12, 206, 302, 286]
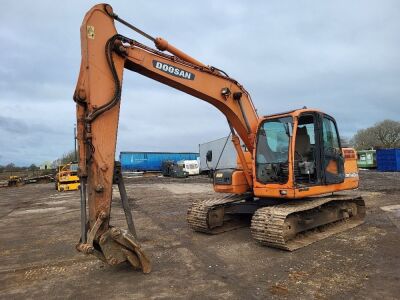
[73, 4, 366, 273]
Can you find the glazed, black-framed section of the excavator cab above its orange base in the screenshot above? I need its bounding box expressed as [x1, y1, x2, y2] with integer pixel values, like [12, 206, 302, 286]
[256, 110, 345, 186]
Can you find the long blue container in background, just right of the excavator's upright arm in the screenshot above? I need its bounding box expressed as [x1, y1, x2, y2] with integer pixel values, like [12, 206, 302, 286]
[119, 152, 199, 171]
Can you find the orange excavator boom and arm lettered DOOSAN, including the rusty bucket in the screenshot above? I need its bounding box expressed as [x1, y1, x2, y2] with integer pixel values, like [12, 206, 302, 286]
[74, 4, 259, 272]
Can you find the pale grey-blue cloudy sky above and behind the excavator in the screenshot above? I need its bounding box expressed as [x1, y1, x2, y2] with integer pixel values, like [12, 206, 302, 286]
[0, 0, 400, 166]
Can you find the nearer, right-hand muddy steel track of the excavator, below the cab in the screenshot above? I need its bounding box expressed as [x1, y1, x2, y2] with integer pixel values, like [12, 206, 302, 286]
[251, 193, 365, 251]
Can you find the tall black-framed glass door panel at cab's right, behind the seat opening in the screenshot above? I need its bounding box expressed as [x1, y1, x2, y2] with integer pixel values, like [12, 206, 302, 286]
[321, 114, 345, 184]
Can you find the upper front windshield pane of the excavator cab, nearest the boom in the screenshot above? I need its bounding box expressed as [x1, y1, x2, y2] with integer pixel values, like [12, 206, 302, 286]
[256, 117, 293, 164]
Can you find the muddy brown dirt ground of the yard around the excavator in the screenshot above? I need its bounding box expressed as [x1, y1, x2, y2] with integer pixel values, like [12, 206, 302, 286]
[0, 171, 400, 299]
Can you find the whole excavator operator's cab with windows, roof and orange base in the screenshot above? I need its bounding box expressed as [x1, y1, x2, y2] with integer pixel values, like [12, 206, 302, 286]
[254, 109, 358, 199]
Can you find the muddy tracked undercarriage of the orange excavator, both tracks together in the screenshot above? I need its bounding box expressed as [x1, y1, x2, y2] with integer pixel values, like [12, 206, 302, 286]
[187, 192, 365, 251]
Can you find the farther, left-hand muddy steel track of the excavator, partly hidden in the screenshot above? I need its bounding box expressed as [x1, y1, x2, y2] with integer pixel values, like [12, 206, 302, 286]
[187, 194, 248, 234]
